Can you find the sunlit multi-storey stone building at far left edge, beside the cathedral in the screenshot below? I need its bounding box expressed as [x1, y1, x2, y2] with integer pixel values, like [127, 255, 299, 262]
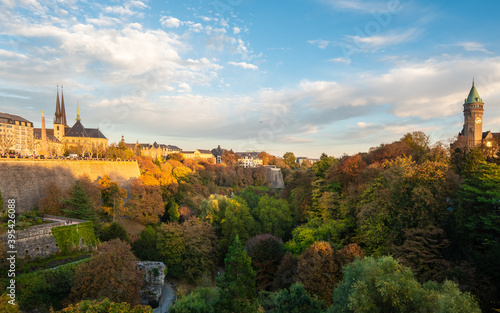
[0, 112, 35, 155]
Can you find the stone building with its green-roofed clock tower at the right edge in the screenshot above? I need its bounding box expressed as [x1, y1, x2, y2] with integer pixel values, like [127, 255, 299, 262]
[456, 81, 500, 148]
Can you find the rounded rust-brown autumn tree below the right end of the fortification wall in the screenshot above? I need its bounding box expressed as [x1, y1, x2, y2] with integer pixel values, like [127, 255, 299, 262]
[127, 179, 164, 225]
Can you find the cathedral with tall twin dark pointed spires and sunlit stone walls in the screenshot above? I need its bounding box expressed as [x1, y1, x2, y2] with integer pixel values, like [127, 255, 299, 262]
[34, 86, 108, 155]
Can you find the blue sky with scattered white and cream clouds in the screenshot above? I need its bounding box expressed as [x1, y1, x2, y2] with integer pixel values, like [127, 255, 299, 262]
[0, 0, 500, 158]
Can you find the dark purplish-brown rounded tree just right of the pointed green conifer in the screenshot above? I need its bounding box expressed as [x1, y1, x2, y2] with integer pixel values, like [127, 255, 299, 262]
[246, 234, 283, 290]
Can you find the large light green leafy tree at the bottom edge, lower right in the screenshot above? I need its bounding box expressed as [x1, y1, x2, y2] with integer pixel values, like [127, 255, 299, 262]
[328, 256, 480, 313]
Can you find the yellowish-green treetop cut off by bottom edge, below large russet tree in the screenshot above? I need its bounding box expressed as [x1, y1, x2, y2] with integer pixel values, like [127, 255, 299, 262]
[50, 298, 153, 313]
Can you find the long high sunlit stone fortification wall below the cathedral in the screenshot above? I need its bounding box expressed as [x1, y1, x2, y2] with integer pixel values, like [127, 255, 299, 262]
[0, 159, 140, 212]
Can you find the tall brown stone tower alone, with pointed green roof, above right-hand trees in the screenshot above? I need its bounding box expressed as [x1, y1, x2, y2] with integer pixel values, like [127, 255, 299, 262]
[461, 80, 484, 148]
